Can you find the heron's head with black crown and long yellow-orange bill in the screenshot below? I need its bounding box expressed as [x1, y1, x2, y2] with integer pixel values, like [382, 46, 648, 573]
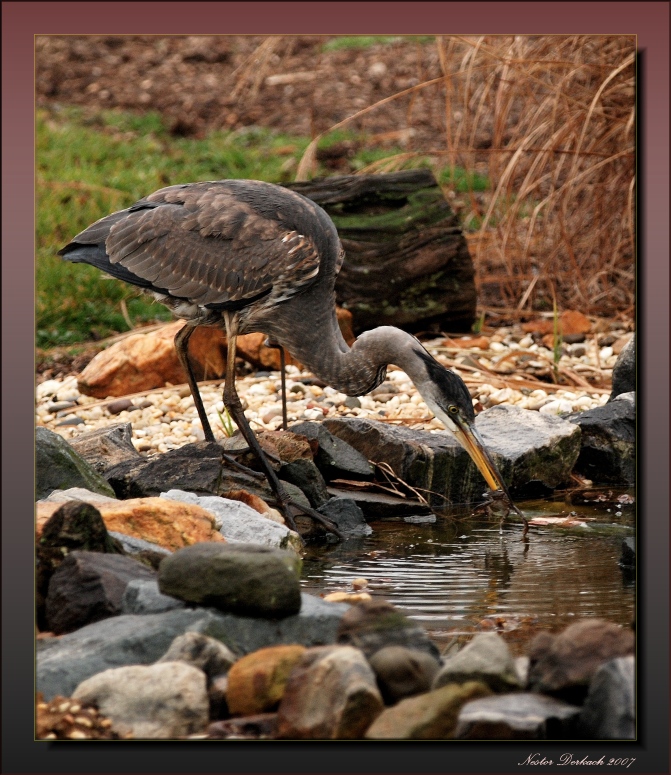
[415, 348, 510, 500]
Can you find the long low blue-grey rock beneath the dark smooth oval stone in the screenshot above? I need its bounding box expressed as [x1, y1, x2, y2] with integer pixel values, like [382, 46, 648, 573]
[37, 596, 350, 701]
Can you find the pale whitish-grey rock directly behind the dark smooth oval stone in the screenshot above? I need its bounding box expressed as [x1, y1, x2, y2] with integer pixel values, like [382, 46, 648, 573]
[161, 490, 302, 552]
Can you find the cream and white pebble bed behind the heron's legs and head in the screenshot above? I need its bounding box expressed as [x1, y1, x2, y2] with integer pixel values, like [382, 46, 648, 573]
[36, 329, 625, 455]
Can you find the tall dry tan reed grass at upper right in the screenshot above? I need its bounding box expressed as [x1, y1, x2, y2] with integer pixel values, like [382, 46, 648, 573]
[297, 35, 636, 315]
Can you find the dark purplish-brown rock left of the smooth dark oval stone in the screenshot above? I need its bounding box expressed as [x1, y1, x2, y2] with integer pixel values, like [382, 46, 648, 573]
[45, 551, 156, 635]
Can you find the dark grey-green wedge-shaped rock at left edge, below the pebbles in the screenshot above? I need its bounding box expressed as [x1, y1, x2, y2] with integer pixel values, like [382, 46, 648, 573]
[35, 427, 114, 500]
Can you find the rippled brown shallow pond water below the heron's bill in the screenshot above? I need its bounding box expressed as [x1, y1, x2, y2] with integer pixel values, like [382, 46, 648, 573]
[302, 491, 635, 651]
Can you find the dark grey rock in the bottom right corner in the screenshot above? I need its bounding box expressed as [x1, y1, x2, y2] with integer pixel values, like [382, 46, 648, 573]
[578, 655, 636, 740]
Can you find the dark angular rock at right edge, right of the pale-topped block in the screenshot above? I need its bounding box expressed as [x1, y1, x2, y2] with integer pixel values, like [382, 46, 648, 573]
[568, 400, 636, 485]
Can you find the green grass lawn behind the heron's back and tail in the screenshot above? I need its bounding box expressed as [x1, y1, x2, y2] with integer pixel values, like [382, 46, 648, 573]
[36, 108, 486, 349]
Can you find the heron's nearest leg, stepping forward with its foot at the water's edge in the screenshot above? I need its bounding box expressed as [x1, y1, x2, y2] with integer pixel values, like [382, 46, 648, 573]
[223, 312, 343, 539]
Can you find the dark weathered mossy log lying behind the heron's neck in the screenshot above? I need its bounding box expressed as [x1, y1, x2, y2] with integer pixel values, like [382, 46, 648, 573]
[286, 170, 476, 333]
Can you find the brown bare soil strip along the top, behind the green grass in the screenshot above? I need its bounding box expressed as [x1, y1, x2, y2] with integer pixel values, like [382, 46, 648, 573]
[36, 35, 456, 152]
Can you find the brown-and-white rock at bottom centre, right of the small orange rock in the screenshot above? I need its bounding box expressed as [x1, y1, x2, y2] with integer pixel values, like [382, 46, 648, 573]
[277, 646, 383, 740]
